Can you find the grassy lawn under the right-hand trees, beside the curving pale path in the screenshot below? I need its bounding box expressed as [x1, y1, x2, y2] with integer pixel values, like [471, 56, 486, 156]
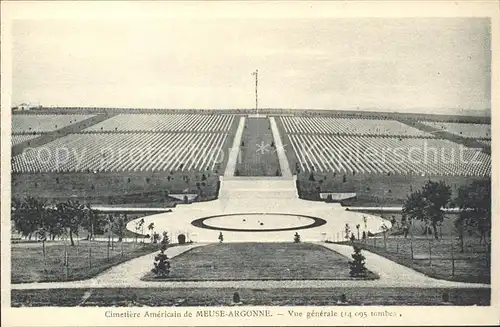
[342, 236, 491, 283]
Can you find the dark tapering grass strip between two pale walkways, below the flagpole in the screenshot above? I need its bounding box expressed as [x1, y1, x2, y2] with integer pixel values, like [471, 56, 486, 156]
[236, 118, 281, 176]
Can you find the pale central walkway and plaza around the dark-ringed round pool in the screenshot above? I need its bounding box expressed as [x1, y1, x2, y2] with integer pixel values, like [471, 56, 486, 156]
[116, 113, 391, 242]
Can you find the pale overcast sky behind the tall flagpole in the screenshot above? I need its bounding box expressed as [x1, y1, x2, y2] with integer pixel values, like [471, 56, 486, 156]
[12, 18, 491, 113]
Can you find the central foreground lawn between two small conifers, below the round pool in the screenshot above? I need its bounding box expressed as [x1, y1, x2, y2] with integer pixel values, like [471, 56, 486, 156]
[144, 243, 378, 281]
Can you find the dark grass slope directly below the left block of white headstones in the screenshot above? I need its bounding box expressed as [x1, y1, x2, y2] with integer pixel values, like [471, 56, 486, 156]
[12, 171, 219, 206]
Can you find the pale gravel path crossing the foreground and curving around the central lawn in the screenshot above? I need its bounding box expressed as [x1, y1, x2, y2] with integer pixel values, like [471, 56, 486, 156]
[12, 243, 491, 289]
